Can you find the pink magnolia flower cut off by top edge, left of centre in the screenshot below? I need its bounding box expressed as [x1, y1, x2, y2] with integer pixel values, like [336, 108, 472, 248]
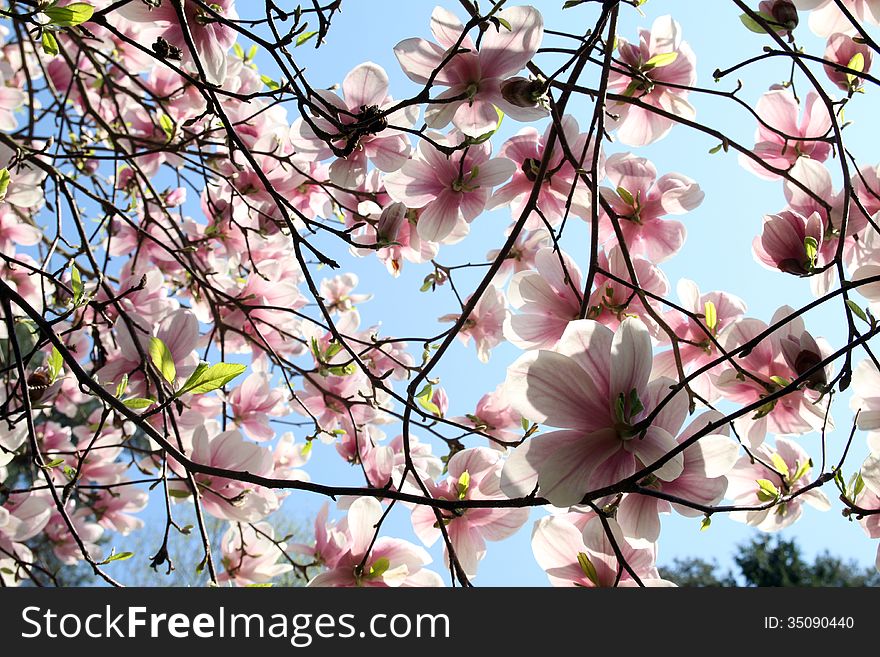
[117, 0, 238, 85]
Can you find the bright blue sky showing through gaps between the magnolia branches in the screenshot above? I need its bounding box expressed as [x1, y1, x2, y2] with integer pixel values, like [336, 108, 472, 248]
[111, 0, 877, 586]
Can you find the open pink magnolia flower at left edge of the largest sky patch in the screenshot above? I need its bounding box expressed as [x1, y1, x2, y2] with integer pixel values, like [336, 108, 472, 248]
[599, 153, 705, 263]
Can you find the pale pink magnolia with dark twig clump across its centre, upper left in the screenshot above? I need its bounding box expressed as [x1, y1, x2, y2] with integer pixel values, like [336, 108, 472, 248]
[291, 62, 417, 188]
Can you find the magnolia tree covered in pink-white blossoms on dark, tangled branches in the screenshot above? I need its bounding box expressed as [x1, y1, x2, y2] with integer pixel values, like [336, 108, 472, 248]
[0, 0, 880, 587]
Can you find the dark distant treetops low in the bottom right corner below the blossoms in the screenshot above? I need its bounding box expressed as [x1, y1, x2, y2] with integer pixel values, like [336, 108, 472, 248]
[661, 536, 880, 587]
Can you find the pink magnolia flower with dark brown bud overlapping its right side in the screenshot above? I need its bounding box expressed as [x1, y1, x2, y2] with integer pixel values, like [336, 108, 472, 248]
[716, 306, 832, 447]
